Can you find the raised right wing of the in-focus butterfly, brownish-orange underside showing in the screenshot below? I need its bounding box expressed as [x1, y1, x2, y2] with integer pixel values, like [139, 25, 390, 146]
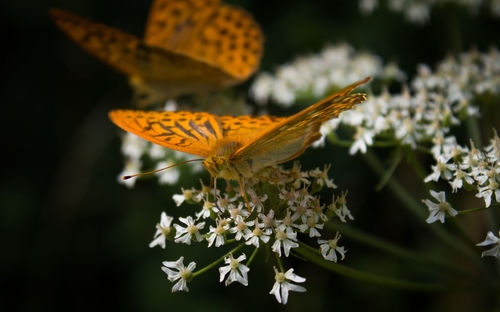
[230, 78, 370, 173]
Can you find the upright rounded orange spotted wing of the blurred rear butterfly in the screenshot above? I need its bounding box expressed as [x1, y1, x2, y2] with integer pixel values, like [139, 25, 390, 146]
[145, 0, 264, 82]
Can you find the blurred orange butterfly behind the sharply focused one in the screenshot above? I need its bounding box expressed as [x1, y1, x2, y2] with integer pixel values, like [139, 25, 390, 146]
[50, 0, 264, 105]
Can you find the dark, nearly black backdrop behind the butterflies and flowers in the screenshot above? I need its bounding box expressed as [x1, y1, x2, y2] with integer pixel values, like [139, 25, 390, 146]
[0, 0, 500, 311]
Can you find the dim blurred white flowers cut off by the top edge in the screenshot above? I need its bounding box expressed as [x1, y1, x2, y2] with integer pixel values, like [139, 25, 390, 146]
[359, 0, 500, 24]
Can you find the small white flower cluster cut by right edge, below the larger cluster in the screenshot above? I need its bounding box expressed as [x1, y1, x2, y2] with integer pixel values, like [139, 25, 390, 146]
[424, 131, 500, 223]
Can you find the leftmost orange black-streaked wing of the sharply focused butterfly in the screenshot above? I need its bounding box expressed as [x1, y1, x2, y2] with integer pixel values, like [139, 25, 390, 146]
[109, 110, 227, 157]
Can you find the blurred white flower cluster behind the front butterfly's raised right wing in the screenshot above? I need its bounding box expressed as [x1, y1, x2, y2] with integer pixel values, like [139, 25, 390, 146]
[250, 44, 405, 107]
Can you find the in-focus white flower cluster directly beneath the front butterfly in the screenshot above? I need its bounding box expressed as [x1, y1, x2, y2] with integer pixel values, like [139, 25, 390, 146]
[150, 163, 353, 304]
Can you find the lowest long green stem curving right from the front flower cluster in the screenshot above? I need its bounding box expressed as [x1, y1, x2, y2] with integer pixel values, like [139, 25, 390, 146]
[295, 242, 471, 291]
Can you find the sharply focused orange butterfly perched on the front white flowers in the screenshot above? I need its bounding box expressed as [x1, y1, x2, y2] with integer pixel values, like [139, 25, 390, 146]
[109, 78, 370, 205]
